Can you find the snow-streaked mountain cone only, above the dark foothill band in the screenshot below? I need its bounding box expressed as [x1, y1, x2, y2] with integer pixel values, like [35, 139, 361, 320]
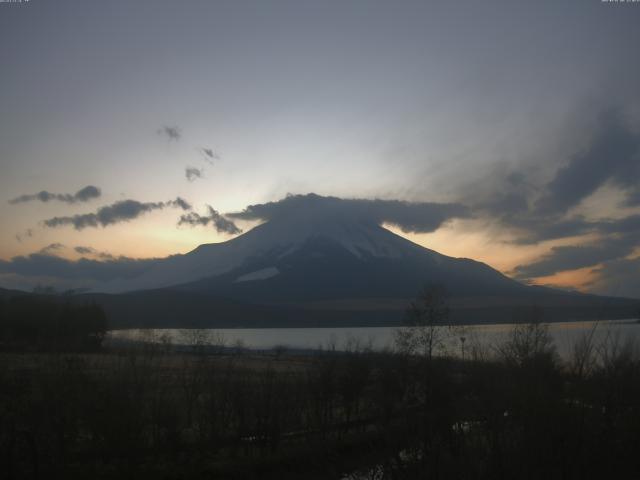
[100, 210, 527, 301]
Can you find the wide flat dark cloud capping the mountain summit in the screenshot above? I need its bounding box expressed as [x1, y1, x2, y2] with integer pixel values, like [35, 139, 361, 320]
[227, 193, 471, 233]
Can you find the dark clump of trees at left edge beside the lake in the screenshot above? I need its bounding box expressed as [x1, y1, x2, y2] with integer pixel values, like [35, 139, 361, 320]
[0, 295, 107, 351]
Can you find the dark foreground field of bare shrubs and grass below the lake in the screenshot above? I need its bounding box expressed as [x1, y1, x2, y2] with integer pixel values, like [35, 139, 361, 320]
[0, 316, 640, 480]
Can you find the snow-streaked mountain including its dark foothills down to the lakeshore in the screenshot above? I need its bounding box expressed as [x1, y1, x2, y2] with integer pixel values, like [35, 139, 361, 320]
[83, 210, 636, 327]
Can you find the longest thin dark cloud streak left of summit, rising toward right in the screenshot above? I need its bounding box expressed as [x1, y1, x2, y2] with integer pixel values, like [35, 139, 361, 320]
[44, 197, 191, 230]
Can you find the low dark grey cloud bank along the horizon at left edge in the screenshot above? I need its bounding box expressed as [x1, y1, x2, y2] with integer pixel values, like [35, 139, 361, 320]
[0, 253, 158, 282]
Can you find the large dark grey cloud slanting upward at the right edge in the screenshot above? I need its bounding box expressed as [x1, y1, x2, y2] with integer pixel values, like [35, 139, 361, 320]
[536, 109, 640, 215]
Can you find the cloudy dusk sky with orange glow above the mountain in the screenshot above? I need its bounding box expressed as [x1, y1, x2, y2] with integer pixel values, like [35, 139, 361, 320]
[0, 0, 640, 297]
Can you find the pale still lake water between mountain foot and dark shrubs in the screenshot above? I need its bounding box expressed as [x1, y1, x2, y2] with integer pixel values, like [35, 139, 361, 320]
[107, 320, 640, 357]
